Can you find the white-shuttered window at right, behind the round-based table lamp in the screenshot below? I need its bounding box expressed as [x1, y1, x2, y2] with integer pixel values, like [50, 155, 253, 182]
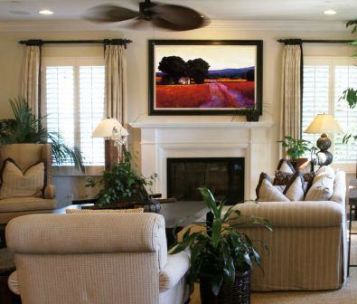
[302, 57, 357, 163]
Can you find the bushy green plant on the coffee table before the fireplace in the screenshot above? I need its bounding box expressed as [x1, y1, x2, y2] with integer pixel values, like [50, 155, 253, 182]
[87, 146, 156, 207]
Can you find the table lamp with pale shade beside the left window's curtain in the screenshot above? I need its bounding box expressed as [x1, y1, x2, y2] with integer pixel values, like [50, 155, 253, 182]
[92, 118, 129, 170]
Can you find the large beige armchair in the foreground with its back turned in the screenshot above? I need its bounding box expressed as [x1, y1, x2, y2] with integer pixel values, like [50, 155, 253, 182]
[6, 213, 189, 304]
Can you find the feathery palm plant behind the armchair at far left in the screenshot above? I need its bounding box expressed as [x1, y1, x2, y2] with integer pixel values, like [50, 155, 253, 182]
[0, 98, 84, 172]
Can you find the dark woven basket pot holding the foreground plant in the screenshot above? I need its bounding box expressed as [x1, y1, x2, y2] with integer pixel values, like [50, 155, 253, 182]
[200, 270, 251, 304]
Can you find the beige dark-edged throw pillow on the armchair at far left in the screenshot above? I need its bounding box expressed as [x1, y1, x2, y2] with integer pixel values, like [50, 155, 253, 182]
[0, 159, 45, 199]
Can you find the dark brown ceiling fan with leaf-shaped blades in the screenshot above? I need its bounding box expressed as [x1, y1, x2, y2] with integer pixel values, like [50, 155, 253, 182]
[84, 0, 208, 31]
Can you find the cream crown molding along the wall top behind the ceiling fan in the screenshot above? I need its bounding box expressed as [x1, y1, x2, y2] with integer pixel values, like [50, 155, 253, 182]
[0, 20, 348, 33]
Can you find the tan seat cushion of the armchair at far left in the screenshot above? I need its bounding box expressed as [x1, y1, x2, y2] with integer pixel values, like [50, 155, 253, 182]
[0, 197, 57, 213]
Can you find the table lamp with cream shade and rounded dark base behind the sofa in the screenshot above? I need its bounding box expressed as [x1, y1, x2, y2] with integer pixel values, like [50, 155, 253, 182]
[304, 113, 343, 166]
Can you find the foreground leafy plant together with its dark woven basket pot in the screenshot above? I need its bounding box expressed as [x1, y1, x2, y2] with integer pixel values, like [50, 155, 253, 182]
[170, 187, 271, 304]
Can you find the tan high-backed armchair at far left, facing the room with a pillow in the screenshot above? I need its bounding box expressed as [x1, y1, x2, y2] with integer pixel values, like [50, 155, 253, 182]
[0, 144, 57, 224]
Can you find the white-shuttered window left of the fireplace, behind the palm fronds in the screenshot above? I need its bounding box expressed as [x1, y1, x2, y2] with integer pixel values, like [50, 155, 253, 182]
[43, 58, 105, 166]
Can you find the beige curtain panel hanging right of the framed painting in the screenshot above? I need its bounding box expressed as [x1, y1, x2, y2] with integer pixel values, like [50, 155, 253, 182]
[280, 43, 302, 139]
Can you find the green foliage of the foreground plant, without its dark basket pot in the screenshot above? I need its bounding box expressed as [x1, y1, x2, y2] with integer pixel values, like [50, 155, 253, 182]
[170, 187, 271, 296]
